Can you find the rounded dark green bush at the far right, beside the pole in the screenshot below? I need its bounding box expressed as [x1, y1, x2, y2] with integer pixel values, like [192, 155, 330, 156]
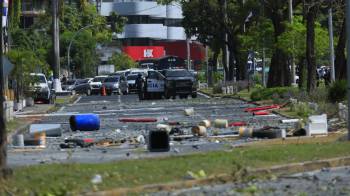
[328, 80, 347, 103]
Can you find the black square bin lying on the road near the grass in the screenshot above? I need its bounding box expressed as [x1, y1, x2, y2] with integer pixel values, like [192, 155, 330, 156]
[148, 130, 170, 152]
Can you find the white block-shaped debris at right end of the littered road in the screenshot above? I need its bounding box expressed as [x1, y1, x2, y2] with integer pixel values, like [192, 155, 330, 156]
[305, 114, 328, 136]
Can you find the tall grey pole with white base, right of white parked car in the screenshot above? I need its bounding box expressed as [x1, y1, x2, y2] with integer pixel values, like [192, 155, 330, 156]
[52, 0, 62, 92]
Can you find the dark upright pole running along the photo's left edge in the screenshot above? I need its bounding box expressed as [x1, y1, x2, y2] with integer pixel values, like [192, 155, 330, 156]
[0, 1, 7, 178]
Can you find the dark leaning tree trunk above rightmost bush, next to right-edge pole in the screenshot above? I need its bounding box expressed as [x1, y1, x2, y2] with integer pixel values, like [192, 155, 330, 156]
[334, 18, 346, 80]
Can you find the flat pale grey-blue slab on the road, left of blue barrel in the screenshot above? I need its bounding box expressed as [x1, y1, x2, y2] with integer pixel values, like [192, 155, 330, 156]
[29, 124, 62, 137]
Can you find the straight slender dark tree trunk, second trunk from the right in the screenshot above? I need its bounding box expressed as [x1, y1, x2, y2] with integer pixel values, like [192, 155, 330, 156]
[306, 4, 318, 93]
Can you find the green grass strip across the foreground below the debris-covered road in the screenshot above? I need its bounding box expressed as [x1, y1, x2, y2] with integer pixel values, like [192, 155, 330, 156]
[0, 138, 350, 195]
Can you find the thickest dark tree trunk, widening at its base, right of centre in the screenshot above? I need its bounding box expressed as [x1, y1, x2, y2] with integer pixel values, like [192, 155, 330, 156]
[267, 8, 291, 87]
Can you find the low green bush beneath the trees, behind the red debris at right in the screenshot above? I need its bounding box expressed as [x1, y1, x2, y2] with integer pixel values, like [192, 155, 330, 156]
[250, 87, 298, 101]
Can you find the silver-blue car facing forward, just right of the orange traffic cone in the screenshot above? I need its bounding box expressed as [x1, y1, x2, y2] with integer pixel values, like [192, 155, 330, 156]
[102, 75, 129, 95]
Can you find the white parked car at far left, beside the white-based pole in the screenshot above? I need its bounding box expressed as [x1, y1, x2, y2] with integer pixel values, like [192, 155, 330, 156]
[26, 73, 55, 103]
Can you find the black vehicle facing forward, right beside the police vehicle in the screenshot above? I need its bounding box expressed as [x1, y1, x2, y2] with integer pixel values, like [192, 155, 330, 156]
[163, 69, 197, 99]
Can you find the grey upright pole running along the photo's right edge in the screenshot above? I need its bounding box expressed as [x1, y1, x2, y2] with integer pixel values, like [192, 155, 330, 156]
[345, 0, 350, 140]
